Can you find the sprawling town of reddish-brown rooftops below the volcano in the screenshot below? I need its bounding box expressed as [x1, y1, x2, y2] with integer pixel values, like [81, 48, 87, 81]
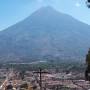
[0, 65, 90, 90]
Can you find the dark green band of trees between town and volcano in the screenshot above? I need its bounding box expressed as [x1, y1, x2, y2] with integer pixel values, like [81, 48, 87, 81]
[0, 60, 85, 72]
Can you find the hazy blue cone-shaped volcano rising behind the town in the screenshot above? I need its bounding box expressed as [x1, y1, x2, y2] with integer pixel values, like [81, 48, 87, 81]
[0, 7, 90, 61]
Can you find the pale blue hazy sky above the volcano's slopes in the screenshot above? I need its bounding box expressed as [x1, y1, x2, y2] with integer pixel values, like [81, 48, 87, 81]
[0, 0, 90, 30]
